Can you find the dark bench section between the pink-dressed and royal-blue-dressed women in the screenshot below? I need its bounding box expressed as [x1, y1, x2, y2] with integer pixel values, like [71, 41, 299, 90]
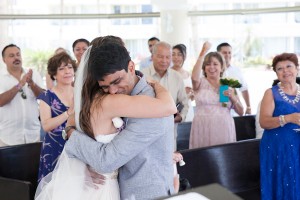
[233, 115, 256, 141]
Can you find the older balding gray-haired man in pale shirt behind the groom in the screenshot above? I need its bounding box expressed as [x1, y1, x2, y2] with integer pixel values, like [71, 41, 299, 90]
[142, 42, 189, 149]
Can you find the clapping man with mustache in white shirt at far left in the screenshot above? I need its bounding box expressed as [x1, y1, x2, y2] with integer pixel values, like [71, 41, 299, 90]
[0, 44, 43, 146]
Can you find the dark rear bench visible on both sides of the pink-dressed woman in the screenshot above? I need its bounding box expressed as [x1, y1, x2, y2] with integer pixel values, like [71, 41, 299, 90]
[177, 115, 256, 150]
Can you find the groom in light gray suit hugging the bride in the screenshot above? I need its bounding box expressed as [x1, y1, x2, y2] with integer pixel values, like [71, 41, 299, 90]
[65, 44, 174, 200]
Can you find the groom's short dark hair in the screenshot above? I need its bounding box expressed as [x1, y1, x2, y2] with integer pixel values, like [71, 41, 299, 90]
[88, 43, 131, 81]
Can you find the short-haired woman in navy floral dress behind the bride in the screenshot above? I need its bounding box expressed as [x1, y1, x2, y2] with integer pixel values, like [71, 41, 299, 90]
[38, 52, 77, 181]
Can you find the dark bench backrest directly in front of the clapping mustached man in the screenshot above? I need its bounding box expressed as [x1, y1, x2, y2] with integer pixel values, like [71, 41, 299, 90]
[0, 142, 42, 199]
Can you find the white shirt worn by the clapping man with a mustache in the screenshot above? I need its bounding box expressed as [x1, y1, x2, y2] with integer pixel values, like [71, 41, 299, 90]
[0, 68, 43, 145]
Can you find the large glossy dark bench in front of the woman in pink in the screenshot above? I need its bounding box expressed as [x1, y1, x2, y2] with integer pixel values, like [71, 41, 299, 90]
[177, 139, 260, 200]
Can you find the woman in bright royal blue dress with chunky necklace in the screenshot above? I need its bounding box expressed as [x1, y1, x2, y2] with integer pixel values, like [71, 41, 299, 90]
[260, 53, 300, 200]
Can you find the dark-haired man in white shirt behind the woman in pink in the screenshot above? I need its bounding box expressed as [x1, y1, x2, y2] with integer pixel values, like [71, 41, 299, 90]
[217, 43, 251, 114]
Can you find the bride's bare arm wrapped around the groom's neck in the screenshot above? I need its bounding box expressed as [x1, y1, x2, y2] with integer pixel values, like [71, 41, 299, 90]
[101, 82, 177, 118]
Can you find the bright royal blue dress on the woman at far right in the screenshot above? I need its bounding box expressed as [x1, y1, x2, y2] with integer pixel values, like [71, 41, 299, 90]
[260, 85, 300, 200]
